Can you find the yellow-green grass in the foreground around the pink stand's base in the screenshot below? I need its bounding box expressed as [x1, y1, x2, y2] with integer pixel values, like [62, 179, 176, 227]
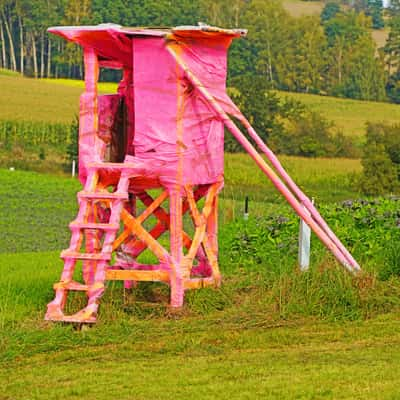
[0, 253, 400, 399]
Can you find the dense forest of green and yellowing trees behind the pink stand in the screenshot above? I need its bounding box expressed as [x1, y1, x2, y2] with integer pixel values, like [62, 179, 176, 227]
[0, 0, 400, 102]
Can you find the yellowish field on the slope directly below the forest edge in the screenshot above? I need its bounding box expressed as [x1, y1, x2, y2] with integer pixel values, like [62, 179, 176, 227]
[0, 74, 400, 136]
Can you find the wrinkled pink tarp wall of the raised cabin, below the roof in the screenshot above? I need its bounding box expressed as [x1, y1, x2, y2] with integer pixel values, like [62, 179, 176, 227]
[133, 37, 226, 185]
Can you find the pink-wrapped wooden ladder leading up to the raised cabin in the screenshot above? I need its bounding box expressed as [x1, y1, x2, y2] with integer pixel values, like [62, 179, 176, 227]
[45, 163, 129, 323]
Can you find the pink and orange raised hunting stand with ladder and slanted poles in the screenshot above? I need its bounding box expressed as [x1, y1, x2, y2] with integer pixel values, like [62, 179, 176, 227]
[46, 24, 359, 323]
